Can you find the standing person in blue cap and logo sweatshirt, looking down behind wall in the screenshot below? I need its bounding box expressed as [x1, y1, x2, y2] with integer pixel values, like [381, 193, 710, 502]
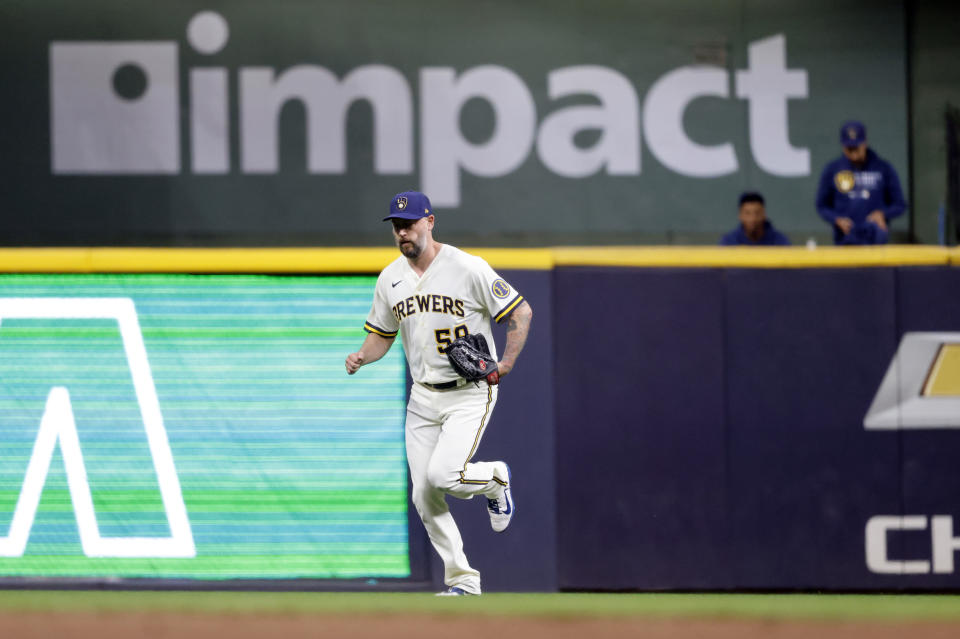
[817, 121, 907, 244]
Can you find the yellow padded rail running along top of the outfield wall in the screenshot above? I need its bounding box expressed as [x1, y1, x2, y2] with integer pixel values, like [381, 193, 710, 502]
[0, 245, 960, 273]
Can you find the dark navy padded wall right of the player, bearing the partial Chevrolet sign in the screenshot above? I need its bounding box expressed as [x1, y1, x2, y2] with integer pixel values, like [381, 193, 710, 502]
[555, 267, 960, 589]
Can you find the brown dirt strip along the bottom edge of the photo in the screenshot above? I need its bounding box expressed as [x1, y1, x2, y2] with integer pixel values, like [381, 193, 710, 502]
[0, 612, 960, 639]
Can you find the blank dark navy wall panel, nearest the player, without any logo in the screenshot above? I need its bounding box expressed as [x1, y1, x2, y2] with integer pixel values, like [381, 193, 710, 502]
[555, 268, 728, 589]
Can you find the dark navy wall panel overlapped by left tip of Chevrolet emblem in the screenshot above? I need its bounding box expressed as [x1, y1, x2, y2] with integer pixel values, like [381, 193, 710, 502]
[725, 268, 900, 589]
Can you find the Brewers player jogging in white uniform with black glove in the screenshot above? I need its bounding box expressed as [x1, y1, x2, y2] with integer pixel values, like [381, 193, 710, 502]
[346, 191, 533, 596]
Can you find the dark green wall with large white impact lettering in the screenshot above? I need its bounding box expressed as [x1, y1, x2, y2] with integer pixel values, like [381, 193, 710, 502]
[0, 0, 909, 246]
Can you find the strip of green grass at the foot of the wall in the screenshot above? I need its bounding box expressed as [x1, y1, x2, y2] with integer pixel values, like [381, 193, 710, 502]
[0, 590, 960, 622]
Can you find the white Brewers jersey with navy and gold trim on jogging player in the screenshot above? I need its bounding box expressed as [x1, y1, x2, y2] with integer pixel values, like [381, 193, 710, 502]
[363, 244, 523, 384]
